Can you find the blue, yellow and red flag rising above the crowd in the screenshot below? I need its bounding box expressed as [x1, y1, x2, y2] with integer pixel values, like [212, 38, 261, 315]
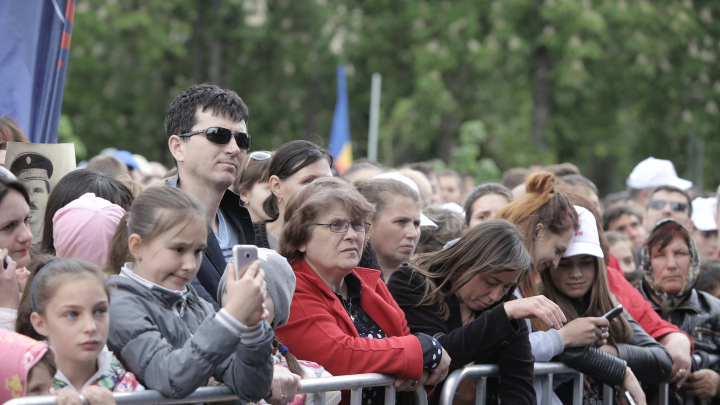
[329, 65, 353, 174]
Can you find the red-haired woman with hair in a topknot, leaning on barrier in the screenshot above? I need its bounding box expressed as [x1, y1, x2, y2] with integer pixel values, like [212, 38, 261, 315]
[496, 172, 641, 404]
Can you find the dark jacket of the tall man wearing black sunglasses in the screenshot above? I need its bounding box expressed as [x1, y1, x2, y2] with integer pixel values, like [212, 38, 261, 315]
[165, 174, 255, 311]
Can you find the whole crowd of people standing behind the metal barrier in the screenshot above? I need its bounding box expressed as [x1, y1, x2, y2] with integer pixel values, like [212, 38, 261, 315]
[0, 84, 720, 405]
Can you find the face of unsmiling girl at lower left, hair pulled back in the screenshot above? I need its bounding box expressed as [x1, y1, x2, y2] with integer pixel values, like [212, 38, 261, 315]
[31, 275, 110, 364]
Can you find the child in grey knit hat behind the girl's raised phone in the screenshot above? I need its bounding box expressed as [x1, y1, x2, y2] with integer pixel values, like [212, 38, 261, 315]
[217, 248, 340, 405]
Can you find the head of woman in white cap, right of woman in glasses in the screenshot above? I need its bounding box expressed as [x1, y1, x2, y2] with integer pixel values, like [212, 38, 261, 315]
[358, 173, 437, 281]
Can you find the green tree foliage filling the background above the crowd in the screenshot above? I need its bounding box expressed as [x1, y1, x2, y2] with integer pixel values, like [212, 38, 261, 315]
[63, 0, 720, 192]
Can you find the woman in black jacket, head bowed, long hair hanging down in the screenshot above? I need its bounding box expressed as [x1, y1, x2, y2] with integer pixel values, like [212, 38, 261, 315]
[388, 219, 565, 404]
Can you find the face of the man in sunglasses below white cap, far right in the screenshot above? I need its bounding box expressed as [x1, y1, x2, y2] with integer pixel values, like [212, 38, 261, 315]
[645, 186, 693, 234]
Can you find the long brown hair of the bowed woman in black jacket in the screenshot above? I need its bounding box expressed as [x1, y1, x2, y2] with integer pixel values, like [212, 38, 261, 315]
[410, 219, 534, 319]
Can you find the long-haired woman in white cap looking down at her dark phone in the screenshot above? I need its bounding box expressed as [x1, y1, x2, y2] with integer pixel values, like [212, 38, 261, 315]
[540, 200, 672, 403]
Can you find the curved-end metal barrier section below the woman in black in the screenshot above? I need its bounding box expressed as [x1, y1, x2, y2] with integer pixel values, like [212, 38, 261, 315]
[440, 363, 583, 405]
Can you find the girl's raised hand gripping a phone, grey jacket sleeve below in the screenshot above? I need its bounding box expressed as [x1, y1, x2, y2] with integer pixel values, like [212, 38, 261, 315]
[223, 260, 267, 326]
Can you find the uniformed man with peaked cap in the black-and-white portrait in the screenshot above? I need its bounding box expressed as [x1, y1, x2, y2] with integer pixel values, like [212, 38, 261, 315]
[10, 152, 53, 239]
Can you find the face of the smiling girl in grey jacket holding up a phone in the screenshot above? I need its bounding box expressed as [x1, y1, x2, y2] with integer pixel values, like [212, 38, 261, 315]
[130, 218, 208, 291]
